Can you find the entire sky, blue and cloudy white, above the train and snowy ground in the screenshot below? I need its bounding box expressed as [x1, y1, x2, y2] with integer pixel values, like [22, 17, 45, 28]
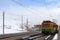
[0, 0, 60, 25]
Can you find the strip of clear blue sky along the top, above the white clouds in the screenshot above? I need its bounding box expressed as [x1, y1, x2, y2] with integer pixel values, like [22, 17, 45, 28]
[0, 0, 60, 9]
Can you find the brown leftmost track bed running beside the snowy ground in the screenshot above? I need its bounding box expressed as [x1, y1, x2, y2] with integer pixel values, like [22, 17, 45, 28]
[0, 32, 41, 40]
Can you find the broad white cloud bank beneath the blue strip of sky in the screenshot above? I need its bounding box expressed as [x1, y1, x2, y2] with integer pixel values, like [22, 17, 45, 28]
[5, 6, 60, 24]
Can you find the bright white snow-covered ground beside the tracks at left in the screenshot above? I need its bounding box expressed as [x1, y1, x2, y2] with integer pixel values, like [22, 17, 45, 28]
[0, 28, 27, 34]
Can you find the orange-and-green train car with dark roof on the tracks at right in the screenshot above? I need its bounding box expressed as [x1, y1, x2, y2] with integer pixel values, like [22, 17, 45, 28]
[41, 20, 58, 34]
